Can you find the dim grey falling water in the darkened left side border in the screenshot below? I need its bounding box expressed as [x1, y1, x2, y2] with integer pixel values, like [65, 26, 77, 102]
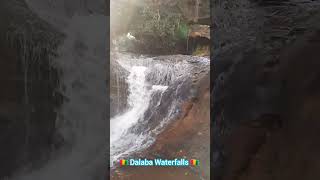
[13, 0, 108, 180]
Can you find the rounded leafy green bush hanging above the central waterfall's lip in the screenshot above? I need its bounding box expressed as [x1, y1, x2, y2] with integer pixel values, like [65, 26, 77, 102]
[129, 5, 189, 50]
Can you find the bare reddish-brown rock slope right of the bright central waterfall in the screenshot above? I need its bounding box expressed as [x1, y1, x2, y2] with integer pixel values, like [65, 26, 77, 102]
[148, 72, 210, 179]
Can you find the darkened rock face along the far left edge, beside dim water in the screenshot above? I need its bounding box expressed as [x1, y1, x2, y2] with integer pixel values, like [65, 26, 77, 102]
[0, 0, 63, 178]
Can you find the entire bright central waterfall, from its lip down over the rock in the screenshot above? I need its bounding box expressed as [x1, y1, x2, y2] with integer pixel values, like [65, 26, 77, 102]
[110, 53, 209, 167]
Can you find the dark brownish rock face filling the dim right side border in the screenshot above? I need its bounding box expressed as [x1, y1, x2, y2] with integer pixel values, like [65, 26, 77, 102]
[212, 0, 320, 180]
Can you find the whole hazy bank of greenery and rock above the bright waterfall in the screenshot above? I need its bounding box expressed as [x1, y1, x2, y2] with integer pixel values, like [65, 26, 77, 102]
[111, 0, 209, 55]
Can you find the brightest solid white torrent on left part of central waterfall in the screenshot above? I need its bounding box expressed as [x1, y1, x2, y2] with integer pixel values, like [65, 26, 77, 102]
[110, 66, 167, 164]
